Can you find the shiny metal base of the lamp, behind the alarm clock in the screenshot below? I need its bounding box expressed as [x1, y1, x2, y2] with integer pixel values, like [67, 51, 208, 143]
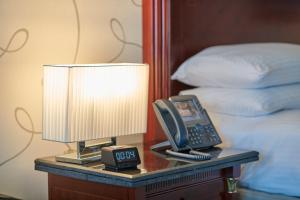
[55, 137, 117, 165]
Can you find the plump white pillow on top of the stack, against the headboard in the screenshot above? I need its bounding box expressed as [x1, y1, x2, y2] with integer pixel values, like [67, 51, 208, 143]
[172, 43, 300, 88]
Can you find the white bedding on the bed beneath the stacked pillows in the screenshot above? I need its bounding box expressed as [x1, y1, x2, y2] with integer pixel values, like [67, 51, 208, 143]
[209, 110, 300, 196]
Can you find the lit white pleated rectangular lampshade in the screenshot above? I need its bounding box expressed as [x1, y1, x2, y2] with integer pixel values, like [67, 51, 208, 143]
[43, 63, 149, 142]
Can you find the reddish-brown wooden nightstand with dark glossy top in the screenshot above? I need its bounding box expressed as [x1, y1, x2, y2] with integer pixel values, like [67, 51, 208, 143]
[35, 145, 258, 200]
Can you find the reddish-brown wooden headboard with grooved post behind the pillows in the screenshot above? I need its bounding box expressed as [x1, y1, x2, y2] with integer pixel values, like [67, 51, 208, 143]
[143, 0, 300, 143]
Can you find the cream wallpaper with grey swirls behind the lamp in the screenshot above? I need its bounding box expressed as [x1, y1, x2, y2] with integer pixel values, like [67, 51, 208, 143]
[0, 0, 142, 200]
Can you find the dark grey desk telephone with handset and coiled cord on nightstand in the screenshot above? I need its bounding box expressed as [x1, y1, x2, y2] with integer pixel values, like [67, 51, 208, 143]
[153, 95, 222, 160]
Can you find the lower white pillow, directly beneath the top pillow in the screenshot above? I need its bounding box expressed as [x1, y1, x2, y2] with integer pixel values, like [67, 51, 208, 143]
[180, 84, 300, 117]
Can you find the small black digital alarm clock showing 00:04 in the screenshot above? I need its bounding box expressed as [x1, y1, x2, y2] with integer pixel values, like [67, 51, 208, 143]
[101, 145, 141, 171]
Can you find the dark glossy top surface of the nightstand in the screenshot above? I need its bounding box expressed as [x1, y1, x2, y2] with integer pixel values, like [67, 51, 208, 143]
[35, 144, 258, 187]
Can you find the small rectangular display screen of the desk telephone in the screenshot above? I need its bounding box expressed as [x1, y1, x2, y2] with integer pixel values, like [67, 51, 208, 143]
[174, 100, 201, 121]
